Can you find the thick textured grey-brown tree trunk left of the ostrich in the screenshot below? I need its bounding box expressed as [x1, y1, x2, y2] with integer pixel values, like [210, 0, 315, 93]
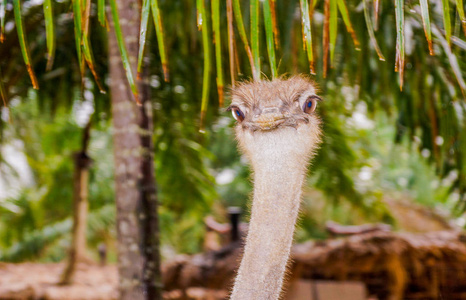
[109, 0, 162, 300]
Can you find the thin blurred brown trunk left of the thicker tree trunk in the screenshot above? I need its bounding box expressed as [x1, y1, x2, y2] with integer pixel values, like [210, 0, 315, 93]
[61, 118, 92, 284]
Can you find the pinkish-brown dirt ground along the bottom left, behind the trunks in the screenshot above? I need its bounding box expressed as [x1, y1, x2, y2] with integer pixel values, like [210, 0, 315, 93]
[0, 262, 228, 300]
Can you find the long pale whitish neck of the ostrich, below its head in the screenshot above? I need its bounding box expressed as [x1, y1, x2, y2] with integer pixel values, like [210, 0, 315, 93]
[231, 142, 308, 300]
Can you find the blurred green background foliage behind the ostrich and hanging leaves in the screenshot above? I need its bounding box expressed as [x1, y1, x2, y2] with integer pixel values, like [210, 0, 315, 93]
[0, 0, 466, 261]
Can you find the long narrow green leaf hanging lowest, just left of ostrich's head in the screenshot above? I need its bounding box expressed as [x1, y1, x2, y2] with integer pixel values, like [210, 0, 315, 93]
[196, 0, 211, 132]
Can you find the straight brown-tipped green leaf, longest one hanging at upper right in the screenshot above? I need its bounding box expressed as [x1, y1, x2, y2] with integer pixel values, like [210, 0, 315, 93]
[395, 0, 405, 90]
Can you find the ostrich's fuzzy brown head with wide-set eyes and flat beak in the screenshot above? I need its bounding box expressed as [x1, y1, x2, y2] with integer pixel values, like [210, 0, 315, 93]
[228, 77, 320, 161]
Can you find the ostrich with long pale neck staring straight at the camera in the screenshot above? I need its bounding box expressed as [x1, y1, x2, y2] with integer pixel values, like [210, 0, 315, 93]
[228, 76, 320, 300]
